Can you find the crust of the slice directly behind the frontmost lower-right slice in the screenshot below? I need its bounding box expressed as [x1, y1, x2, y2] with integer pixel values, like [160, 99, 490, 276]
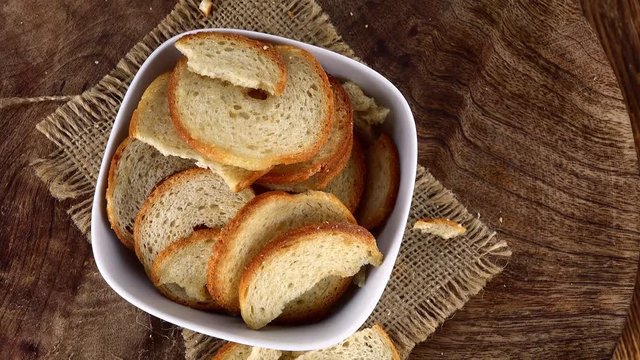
[207, 191, 356, 314]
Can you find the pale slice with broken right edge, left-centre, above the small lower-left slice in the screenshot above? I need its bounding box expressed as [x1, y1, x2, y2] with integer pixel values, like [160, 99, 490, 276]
[133, 169, 254, 273]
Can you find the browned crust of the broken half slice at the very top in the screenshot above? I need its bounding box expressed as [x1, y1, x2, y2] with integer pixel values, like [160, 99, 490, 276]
[176, 32, 287, 96]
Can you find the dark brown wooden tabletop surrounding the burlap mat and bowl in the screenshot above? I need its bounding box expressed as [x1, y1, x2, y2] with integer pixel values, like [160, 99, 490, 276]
[0, 0, 640, 359]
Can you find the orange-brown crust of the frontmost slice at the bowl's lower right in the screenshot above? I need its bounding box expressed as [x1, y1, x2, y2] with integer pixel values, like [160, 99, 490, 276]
[238, 222, 383, 328]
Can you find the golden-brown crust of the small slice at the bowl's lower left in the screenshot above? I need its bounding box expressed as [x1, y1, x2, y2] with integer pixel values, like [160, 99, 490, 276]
[149, 229, 220, 310]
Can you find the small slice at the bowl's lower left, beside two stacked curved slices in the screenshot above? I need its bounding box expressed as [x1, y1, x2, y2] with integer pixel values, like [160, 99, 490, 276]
[150, 229, 220, 310]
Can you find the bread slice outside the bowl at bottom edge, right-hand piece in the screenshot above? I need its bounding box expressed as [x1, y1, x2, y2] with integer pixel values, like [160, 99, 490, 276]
[296, 325, 400, 360]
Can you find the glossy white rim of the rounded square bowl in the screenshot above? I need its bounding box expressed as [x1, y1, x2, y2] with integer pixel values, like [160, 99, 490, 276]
[91, 28, 418, 351]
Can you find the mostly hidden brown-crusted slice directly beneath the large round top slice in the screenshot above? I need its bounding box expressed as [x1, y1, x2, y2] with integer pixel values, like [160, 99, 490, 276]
[258, 77, 353, 184]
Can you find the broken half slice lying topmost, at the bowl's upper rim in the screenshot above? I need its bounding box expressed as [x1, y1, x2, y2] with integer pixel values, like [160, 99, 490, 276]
[176, 32, 287, 95]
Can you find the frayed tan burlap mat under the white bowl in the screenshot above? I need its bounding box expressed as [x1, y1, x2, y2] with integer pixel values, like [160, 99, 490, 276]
[32, 0, 511, 359]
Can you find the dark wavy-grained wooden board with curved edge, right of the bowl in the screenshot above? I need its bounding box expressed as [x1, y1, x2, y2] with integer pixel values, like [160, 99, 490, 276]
[323, 1, 640, 359]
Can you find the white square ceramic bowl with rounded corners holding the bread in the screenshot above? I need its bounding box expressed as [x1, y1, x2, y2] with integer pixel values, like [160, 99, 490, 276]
[91, 29, 417, 351]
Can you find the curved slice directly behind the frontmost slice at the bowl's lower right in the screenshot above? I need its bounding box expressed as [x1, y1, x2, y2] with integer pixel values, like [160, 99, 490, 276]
[207, 191, 355, 313]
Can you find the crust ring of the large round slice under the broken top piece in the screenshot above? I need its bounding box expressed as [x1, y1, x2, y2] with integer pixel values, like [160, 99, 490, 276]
[168, 45, 333, 170]
